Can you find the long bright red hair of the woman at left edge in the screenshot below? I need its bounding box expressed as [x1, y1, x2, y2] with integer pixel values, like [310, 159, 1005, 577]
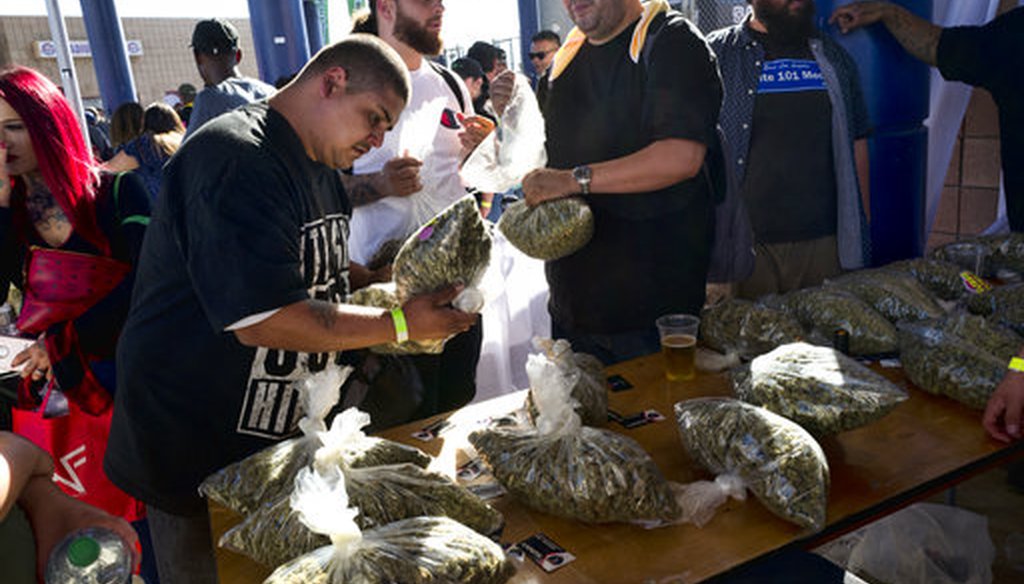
[0, 67, 111, 255]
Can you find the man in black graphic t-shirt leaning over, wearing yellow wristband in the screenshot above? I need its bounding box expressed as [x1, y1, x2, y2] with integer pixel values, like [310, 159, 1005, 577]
[104, 35, 476, 584]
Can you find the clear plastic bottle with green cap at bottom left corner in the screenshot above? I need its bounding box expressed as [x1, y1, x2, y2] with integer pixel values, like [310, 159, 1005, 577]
[46, 528, 132, 584]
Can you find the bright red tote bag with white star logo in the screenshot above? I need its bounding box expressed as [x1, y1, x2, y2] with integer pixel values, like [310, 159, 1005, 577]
[11, 383, 145, 522]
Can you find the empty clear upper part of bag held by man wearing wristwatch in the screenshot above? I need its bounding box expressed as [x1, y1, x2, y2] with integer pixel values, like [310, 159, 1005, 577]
[461, 75, 548, 193]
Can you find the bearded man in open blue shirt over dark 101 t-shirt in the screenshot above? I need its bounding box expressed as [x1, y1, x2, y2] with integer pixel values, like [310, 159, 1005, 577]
[708, 0, 869, 299]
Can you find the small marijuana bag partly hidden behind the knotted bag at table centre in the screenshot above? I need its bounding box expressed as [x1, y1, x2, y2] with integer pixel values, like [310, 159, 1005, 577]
[526, 337, 608, 426]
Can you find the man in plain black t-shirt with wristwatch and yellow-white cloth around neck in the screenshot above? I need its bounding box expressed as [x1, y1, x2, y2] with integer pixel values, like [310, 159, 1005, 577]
[523, 0, 722, 364]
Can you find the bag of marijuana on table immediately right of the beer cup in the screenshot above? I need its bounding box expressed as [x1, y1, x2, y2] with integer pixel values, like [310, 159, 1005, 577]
[700, 298, 804, 359]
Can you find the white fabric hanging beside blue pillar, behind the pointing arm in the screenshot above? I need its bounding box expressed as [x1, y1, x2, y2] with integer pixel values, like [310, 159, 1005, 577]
[925, 0, 1008, 234]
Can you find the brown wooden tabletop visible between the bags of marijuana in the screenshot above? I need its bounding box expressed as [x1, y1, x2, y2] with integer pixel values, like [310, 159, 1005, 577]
[211, 354, 1024, 584]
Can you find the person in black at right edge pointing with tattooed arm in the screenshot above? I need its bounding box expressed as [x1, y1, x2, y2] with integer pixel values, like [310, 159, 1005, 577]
[830, 2, 1024, 232]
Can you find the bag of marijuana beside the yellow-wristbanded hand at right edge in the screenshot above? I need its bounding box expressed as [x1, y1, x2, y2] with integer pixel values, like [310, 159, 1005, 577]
[899, 322, 1007, 410]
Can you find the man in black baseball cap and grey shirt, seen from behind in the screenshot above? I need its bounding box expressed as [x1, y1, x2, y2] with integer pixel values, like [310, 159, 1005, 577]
[185, 18, 274, 136]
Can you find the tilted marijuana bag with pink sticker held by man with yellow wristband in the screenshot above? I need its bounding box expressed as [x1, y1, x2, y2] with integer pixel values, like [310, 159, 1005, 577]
[391, 195, 492, 304]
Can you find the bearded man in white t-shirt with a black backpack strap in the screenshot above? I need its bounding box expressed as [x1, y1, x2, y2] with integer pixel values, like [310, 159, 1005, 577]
[343, 0, 490, 418]
